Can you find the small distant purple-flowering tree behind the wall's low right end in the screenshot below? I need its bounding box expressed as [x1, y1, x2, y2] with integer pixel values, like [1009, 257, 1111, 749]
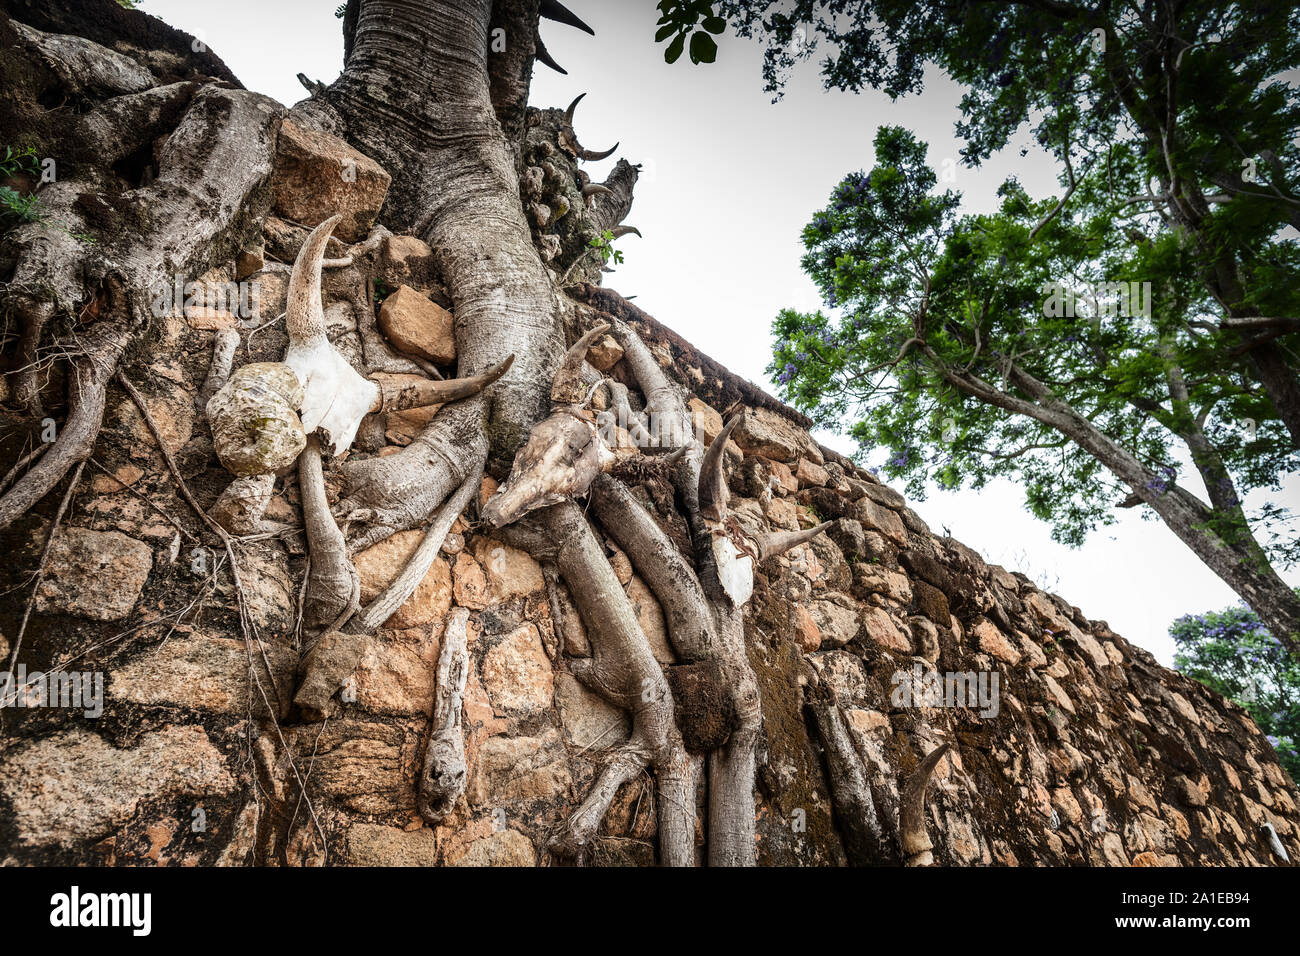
[1169, 592, 1300, 780]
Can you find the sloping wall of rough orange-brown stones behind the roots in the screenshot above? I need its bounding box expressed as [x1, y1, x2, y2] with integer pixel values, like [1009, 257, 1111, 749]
[0, 18, 1300, 865]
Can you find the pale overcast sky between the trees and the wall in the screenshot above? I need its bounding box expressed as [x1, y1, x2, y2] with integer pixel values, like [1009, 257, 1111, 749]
[142, 0, 1300, 663]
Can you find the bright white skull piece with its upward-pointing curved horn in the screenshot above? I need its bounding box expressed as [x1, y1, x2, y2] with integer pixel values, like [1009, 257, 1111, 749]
[285, 216, 380, 455]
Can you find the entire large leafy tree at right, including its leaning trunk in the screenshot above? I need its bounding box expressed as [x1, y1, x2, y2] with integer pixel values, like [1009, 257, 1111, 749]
[676, 0, 1300, 654]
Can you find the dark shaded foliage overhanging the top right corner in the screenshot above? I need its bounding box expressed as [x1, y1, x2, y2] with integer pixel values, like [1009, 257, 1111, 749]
[681, 0, 1300, 445]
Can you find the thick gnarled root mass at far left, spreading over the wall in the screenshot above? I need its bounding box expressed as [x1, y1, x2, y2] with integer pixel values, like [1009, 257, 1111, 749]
[0, 70, 278, 528]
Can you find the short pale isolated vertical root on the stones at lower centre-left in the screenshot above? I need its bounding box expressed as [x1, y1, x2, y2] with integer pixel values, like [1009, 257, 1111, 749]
[416, 607, 469, 826]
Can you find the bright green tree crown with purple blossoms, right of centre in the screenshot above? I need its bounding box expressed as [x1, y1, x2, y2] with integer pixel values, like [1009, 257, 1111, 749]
[768, 127, 1300, 563]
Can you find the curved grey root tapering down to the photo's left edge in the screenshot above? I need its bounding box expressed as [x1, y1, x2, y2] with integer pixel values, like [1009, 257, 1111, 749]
[0, 326, 130, 531]
